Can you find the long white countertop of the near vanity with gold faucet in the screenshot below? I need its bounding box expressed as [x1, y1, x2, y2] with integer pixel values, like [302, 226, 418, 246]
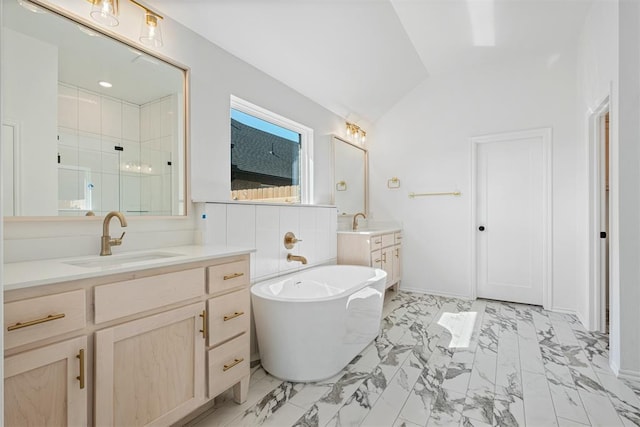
[3, 245, 255, 291]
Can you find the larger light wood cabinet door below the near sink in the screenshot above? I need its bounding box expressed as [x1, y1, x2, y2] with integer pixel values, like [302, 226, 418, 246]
[95, 303, 206, 426]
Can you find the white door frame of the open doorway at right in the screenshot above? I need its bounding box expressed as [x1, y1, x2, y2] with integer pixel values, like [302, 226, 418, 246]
[587, 95, 613, 331]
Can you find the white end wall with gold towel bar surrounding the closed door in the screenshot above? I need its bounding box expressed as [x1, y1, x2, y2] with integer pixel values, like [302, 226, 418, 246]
[369, 53, 586, 311]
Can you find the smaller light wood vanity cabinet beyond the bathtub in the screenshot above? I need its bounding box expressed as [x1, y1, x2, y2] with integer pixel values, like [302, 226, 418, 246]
[338, 231, 402, 290]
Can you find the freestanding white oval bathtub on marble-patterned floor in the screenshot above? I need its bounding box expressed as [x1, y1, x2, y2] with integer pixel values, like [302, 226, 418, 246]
[251, 265, 387, 382]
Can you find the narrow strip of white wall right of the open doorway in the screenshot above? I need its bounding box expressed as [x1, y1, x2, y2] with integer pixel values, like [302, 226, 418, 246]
[611, 0, 640, 380]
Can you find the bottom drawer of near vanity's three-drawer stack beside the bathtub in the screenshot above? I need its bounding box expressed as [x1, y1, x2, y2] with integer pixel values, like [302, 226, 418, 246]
[207, 334, 249, 398]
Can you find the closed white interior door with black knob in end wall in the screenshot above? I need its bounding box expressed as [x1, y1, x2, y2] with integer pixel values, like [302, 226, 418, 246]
[474, 131, 549, 305]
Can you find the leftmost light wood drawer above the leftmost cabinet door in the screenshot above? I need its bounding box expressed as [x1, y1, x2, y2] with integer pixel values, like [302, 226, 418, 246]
[4, 289, 87, 349]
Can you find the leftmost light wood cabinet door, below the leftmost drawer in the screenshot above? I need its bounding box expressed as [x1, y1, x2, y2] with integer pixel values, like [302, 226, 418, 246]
[4, 337, 87, 426]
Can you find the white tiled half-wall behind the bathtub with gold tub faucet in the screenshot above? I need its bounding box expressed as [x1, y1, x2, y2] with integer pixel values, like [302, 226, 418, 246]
[199, 203, 337, 282]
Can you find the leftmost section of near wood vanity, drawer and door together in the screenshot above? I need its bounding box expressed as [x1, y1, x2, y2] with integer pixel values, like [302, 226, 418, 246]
[4, 289, 87, 426]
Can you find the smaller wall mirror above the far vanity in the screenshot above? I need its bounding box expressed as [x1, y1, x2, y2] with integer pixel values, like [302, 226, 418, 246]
[333, 136, 368, 215]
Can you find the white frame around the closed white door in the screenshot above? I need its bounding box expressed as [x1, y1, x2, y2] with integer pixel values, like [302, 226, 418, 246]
[469, 128, 553, 310]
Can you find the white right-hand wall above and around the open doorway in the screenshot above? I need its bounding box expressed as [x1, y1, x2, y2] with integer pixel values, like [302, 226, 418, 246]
[578, 0, 640, 380]
